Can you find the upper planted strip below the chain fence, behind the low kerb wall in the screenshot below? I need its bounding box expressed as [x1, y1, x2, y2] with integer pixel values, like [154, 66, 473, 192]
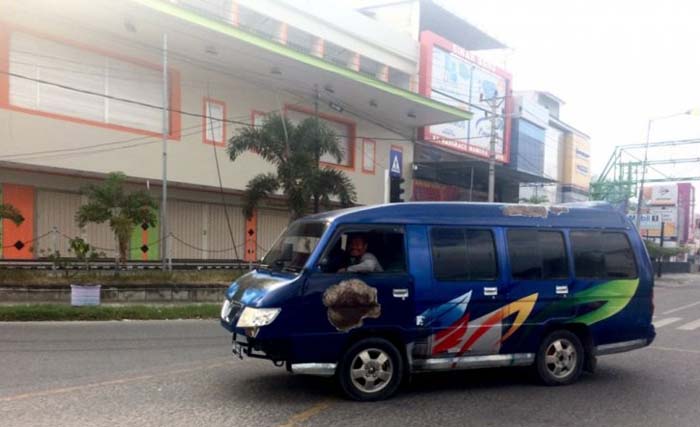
[0, 270, 248, 286]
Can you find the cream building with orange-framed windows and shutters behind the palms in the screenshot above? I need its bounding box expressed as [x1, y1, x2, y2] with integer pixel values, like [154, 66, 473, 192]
[0, 0, 471, 260]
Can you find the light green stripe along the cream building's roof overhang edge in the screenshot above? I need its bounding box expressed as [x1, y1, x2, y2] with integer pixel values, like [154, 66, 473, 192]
[133, 0, 472, 121]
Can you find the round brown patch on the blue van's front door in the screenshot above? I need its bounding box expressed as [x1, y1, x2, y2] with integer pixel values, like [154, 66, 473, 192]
[323, 279, 382, 332]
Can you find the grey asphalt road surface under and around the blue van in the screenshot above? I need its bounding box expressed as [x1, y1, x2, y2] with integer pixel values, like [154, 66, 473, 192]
[0, 277, 700, 427]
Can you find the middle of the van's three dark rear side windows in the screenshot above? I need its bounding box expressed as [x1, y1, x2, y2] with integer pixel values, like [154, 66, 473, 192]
[508, 229, 569, 280]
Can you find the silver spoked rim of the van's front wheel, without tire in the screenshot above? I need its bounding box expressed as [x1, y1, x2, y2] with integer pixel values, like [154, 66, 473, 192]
[350, 348, 394, 393]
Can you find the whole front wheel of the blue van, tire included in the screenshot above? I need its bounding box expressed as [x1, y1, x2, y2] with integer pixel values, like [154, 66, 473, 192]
[336, 338, 404, 402]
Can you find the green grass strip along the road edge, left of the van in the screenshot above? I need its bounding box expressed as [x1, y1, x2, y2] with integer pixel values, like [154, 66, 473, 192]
[0, 304, 221, 322]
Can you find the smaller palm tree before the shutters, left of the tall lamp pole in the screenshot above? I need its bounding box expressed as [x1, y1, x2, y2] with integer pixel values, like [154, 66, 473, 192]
[75, 172, 158, 263]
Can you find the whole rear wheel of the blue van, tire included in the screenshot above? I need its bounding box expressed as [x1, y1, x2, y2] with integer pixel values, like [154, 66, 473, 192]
[535, 330, 586, 386]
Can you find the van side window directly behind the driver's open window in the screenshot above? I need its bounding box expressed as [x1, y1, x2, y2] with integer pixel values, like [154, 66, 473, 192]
[431, 227, 498, 281]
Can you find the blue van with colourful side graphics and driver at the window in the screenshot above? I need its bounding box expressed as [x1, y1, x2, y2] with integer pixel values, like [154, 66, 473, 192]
[221, 203, 655, 400]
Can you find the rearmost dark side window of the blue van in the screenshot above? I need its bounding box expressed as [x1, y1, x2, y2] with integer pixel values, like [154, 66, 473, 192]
[571, 231, 637, 279]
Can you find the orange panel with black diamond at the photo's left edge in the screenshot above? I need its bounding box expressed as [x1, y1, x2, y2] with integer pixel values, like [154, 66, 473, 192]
[2, 184, 34, 259]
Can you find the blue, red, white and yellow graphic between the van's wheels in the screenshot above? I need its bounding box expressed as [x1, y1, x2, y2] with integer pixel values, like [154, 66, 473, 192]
[422, 291, 538, 356]
